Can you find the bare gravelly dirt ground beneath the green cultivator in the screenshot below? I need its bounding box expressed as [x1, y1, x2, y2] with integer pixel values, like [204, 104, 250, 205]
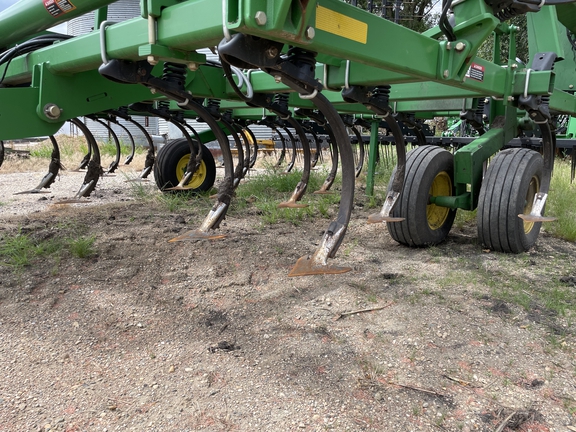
[0, 160, 576, 432]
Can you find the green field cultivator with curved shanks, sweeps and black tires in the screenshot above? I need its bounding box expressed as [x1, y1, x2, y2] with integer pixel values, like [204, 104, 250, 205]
[0, 0, 576, 276]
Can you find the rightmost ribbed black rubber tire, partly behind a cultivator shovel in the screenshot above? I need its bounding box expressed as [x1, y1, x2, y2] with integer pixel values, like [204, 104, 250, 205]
[477, 148, 544, 253]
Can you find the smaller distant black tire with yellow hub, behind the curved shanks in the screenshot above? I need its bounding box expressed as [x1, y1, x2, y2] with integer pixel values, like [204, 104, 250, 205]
[154, 138, 216, 193]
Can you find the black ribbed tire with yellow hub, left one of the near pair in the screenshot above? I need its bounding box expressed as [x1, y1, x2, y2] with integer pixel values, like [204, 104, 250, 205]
[386, 145, 456, 247]
